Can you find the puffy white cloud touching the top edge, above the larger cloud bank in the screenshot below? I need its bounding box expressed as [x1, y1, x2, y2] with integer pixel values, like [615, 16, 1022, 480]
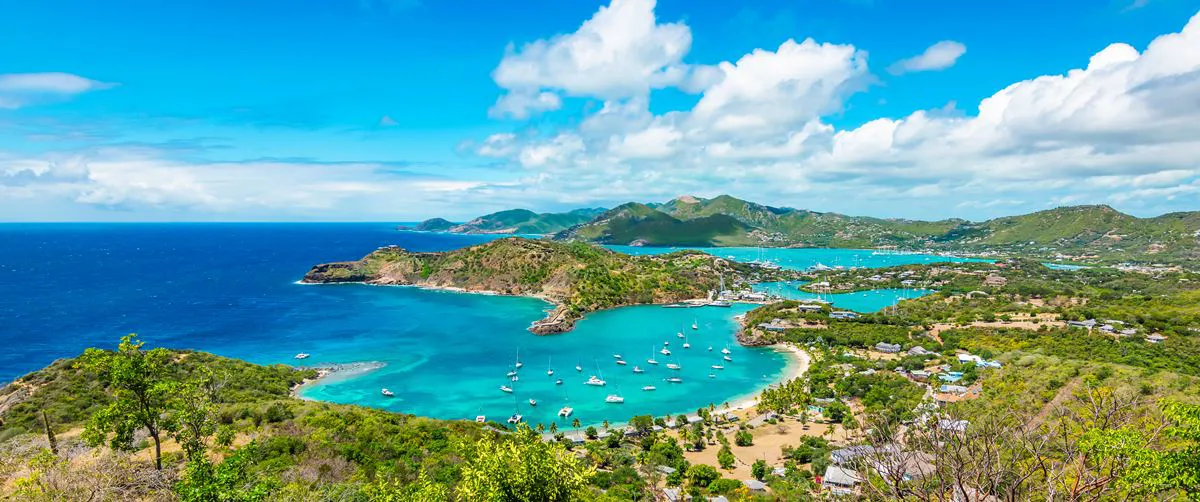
[492, 0, 700, 118]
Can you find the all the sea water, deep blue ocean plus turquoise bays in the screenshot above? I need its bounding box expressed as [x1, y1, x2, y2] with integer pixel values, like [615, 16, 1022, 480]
[0, 223, 969, 426]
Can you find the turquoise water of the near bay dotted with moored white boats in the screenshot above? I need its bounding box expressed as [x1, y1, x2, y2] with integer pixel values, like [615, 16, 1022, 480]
[302, 301, 786, 428]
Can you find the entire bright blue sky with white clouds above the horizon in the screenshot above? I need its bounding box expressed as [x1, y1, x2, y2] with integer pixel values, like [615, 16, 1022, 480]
[0, 0, 1200, 221]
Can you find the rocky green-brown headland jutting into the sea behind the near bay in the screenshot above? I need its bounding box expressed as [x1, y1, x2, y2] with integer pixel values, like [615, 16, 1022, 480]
[304, 238, 790, 334]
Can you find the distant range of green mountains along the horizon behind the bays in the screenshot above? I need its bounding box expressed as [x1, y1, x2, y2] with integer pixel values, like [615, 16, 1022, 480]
[410, 196, 1200, 263]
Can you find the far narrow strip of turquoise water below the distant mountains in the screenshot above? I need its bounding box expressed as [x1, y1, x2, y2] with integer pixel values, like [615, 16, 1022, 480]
[606, 246, 986, 270]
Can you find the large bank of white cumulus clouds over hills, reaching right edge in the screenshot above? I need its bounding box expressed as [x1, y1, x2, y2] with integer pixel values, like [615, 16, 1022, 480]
[472, 5, 1200, 214]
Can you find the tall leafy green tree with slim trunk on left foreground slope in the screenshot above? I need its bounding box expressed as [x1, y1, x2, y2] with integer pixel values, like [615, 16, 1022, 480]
[79, 334, 175, 470]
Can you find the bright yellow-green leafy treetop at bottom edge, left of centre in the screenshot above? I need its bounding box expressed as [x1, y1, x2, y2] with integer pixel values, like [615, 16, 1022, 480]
[456, 424, 594, 501]
